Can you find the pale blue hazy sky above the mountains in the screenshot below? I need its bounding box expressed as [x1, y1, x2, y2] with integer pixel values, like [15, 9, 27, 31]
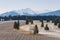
[0, 0, 60, 14]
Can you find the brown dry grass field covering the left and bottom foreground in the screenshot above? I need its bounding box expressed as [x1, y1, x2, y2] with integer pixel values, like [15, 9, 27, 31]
[0, 21, 60, 40]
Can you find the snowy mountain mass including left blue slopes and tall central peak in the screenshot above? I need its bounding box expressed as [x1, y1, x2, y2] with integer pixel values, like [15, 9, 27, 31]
[0, 8, 37, 16]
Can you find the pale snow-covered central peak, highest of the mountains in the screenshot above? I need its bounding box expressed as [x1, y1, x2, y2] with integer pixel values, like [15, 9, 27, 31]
[16, 8, 36, 16]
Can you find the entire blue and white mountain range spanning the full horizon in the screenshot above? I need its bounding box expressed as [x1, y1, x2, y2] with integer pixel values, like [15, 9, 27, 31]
[0, 8, 60, 17]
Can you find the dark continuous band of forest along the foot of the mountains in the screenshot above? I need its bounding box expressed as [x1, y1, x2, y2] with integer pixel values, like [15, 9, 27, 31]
[0, 15, 60, 21]
